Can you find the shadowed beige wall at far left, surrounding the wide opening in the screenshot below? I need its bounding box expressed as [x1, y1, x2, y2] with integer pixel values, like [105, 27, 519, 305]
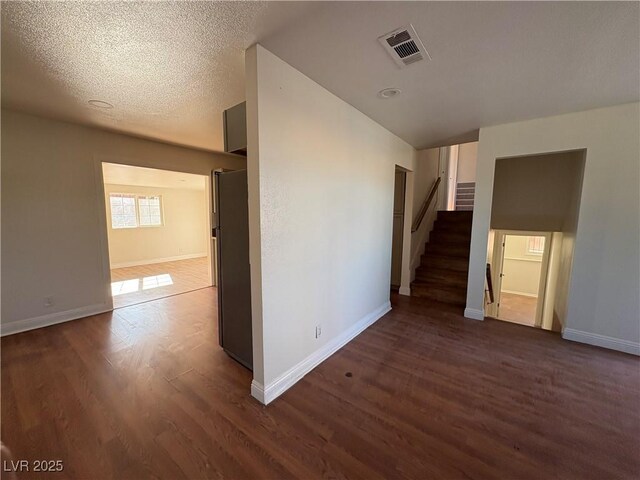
[2, 109, 245, 334]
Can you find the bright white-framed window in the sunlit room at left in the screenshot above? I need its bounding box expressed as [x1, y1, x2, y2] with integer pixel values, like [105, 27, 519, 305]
[109, 193, 162, 229]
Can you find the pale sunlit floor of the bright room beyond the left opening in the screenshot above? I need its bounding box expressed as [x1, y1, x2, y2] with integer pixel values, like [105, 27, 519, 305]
[111, 257, 211, 308]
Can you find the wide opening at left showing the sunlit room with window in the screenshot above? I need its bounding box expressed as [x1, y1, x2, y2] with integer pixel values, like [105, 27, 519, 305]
[102, 162, 213, 308]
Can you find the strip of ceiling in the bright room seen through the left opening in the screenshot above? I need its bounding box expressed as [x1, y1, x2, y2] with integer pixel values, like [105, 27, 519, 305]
[102, 163, 206, 191]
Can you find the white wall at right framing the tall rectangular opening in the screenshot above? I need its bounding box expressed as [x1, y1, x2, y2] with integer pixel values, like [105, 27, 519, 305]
[465, 103, 640, 354]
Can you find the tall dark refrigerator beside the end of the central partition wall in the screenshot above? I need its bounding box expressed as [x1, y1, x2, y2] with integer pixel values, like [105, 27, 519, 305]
[213, 170, 253, 369]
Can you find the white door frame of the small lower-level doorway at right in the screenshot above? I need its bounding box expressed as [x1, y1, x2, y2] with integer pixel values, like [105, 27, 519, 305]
[489, 230, 552, 327]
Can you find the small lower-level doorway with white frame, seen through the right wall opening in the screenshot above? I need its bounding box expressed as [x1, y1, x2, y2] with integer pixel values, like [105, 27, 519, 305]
[493, 231, 551, 328]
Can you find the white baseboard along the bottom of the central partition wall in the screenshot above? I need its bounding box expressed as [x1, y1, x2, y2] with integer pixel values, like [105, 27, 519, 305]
[251, 301, 391, 405]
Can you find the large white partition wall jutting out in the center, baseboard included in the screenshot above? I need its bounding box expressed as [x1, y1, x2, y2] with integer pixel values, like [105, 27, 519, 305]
[246, 45, 415, 403]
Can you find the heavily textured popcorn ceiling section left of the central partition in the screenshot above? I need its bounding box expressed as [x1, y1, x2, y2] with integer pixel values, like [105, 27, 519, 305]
[2, 1, 317, 151]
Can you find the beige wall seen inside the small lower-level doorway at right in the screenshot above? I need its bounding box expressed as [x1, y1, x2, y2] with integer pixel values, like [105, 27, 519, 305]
[502, 235, 542, 297]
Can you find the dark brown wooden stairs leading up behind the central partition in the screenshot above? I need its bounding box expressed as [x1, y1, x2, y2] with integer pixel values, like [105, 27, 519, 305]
[411, 211, 473, 307]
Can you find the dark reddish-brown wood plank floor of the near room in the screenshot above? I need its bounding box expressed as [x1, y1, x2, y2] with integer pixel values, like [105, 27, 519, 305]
[2, 288, 640, 480]
